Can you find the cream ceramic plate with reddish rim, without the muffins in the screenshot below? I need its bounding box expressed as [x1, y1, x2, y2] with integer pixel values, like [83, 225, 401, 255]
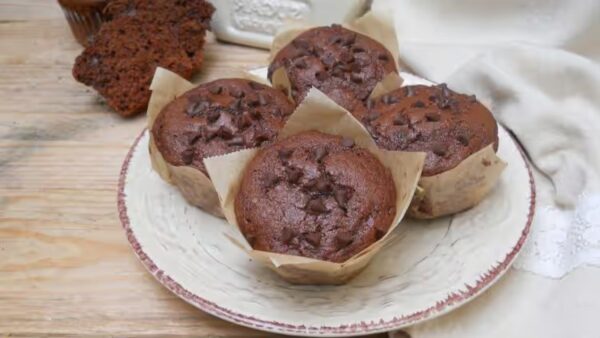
[118, 76, 535, 337]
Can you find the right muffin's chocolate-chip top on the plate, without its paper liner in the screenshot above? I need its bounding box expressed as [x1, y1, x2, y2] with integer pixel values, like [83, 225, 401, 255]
[357, 84, 498, 176]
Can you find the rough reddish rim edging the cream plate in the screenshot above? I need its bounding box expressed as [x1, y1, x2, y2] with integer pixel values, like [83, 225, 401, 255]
[117, 130, 536, 336]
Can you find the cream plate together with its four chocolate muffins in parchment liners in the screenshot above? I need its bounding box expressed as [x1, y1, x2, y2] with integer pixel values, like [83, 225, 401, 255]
[118, 14, 535, 337]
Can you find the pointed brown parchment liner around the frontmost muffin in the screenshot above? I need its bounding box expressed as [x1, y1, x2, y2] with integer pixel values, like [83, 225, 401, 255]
[204, 88, 425, 284]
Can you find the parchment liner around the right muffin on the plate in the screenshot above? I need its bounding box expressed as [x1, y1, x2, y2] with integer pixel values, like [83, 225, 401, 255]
[371, 79, 507, 219]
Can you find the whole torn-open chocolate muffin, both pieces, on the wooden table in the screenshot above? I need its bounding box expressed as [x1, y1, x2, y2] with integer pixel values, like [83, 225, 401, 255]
[73, 0, 214, 116]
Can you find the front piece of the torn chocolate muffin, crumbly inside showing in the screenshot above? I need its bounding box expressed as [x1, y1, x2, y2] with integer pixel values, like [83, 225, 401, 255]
[73, 17, 194, 116]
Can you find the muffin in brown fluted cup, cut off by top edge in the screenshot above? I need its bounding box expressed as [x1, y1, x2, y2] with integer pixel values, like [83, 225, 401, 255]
[58, 0, 108, 47]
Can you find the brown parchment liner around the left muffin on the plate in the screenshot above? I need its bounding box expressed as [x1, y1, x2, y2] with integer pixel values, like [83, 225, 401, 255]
[147, 67, 274, 218]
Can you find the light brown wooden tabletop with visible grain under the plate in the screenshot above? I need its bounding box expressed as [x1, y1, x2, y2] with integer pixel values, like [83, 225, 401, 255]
[0, 0, 385, 337]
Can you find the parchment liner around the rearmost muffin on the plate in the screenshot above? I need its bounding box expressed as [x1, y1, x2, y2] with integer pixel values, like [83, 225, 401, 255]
[269, 11, 401, 103]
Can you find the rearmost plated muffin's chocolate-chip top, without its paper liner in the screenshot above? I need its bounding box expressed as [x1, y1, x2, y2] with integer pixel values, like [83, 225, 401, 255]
[268, 25, 397, 110]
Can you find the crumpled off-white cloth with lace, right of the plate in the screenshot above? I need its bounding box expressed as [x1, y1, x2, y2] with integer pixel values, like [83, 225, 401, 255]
[373, 0, 600, 338]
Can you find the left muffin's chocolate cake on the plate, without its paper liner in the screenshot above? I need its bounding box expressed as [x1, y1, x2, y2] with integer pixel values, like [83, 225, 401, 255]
[152, 79, 294, 174]
